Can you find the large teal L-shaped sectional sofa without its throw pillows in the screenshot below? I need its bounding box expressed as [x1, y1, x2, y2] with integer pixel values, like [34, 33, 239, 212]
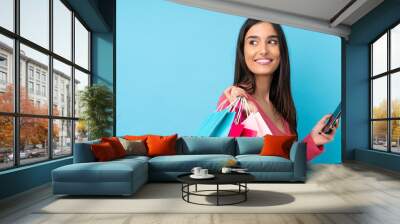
[52, 136, 306, 195]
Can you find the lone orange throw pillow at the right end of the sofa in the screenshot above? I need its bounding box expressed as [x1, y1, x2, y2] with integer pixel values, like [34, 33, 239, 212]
[260, 135, 296, 159]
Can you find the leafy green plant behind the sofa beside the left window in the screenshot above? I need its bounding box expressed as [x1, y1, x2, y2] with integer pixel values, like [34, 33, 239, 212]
[78, 84, 113, 140]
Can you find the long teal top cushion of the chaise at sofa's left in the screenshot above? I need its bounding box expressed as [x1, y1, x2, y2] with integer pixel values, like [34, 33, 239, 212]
[52, 159, 147, 182]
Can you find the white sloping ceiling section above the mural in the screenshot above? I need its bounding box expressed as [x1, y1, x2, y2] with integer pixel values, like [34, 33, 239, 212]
[171, 0, 383, 38]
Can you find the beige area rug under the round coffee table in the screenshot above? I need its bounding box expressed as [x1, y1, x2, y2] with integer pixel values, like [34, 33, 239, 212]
[35, 183, 360, 214]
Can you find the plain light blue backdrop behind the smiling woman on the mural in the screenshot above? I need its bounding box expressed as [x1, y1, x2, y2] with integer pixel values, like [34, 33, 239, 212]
[116, 0, 341, 163]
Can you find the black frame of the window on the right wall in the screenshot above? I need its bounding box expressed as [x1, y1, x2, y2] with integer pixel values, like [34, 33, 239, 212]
[368, 20, 400, 155]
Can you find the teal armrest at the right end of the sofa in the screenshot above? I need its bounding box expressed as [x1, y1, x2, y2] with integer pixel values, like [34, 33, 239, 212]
[290, 142, 307, 181]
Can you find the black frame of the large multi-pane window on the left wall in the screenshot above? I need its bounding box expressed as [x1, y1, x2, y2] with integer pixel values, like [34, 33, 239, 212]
[0, 0, 93, 172]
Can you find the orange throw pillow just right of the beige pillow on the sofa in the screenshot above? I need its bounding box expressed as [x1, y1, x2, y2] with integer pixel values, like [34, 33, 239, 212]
[146, 134, 178, 156]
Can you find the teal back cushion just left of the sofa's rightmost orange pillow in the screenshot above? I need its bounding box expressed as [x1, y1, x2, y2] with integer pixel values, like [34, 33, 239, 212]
[236, 137, 264, 155]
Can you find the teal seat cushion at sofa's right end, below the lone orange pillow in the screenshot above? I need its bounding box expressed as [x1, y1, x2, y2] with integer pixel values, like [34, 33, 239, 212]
[236, 155, 293, 172]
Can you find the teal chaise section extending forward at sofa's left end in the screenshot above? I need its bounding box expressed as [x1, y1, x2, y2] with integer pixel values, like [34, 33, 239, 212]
[52, 158, 148, 195]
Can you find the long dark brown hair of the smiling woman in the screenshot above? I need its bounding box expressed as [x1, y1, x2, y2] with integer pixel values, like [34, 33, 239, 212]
[233, 19, 297, 135]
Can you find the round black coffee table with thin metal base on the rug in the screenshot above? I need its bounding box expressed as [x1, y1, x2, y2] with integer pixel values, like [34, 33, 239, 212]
[177, 173, 255, 206]
